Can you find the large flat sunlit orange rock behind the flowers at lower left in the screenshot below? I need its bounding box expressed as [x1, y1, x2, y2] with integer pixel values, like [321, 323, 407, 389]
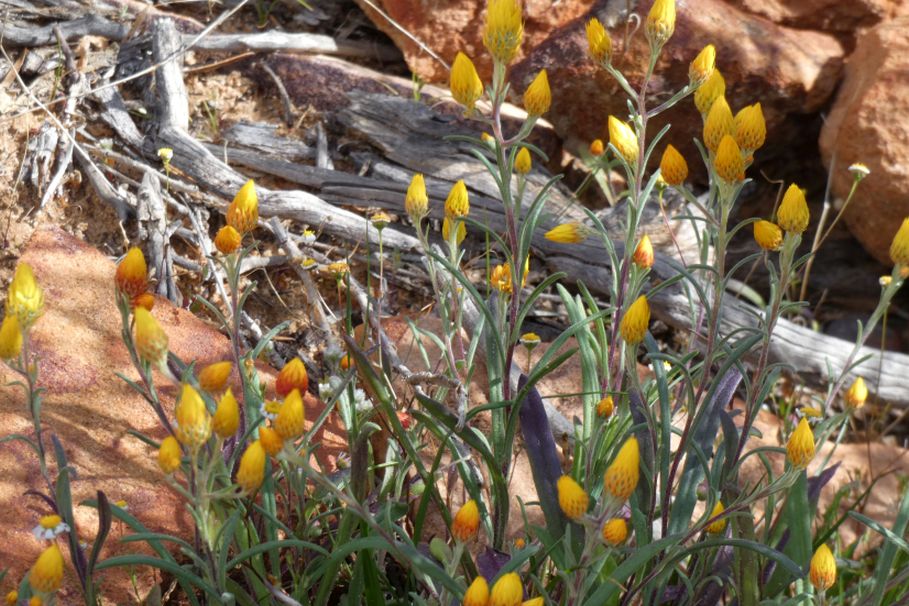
[0, 230, 343, 605]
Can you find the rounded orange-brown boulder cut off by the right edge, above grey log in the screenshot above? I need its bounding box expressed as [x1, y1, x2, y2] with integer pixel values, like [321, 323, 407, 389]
[820, 17, 909, 265]
